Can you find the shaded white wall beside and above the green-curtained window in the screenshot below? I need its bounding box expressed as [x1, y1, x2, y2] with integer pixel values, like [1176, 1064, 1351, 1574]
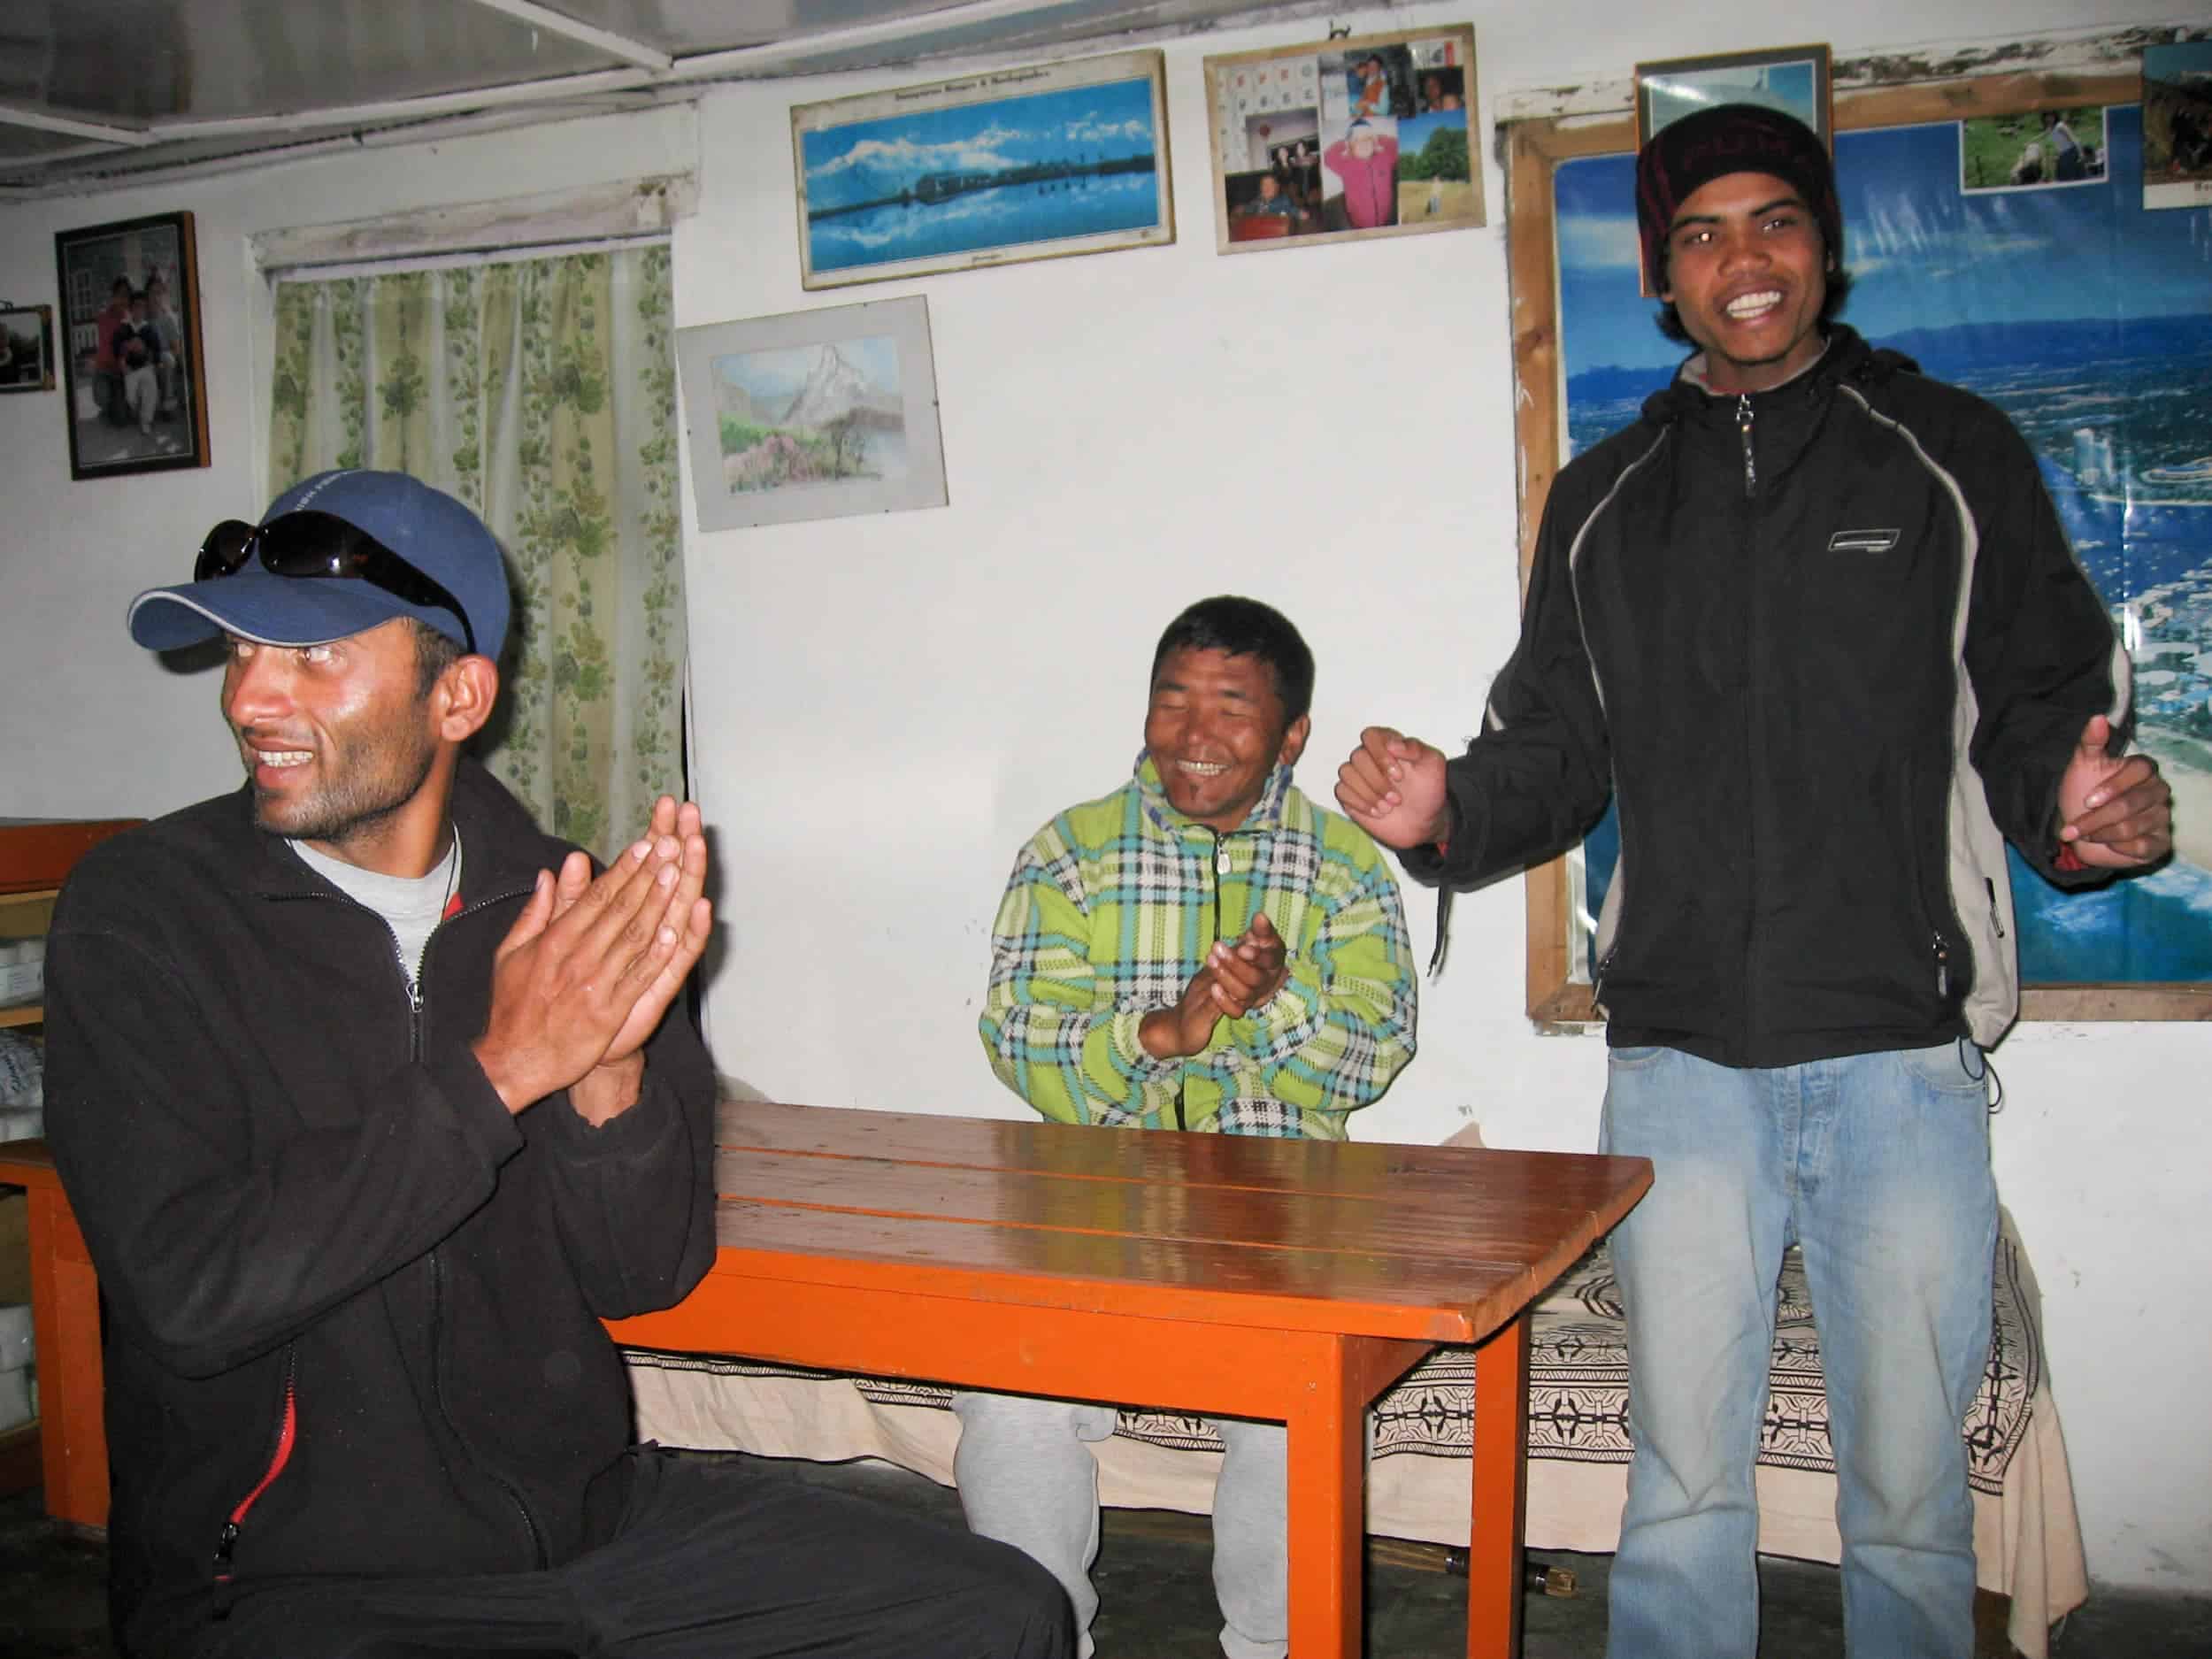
[0, 106, 699, 818]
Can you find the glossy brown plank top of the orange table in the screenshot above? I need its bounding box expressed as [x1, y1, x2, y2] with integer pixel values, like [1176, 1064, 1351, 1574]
[715, 1102, 1650, 1343]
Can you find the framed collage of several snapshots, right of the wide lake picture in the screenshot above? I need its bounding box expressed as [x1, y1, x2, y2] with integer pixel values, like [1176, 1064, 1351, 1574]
[1206, 25, 1482, 255]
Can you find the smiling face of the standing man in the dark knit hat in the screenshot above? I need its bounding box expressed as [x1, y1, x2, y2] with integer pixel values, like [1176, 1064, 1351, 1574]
[1659, 173, 1827, 392]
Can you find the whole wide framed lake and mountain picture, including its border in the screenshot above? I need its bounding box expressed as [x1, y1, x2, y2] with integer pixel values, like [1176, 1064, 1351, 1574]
[792, 51, 1175, 288]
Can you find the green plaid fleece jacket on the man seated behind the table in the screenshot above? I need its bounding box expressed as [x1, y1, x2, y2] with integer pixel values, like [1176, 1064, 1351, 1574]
[980, 757, 1416, 1141]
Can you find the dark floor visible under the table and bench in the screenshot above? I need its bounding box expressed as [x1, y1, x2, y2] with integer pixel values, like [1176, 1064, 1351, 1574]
[0, 1464, 2212, 1659]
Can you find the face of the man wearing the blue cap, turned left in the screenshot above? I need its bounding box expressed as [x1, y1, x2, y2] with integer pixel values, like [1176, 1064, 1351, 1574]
[224, 618, 445, 874]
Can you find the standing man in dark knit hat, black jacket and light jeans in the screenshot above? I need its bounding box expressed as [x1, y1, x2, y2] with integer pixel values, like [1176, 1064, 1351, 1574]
[1336, 106, 2170, 1659]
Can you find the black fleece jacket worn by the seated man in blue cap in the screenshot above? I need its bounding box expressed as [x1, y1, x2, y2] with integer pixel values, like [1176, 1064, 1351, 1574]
[47, 764, 715, 1655]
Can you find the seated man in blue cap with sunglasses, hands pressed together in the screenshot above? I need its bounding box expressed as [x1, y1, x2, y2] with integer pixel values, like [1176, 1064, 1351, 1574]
[47, 472, 1073, 1659]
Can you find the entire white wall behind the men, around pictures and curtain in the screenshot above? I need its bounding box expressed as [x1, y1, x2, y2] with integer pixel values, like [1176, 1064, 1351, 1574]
[0, 0, 2212, 1593]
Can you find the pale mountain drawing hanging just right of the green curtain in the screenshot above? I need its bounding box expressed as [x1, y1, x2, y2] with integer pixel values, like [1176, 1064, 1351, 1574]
[677, 296, 945, 531]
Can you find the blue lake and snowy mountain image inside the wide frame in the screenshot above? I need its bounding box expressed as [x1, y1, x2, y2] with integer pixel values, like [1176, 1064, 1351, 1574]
[799, 80, 1159, 270]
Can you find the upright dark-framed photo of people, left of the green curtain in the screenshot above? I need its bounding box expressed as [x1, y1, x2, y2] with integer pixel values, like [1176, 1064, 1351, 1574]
[53, 212, 208, 478]
